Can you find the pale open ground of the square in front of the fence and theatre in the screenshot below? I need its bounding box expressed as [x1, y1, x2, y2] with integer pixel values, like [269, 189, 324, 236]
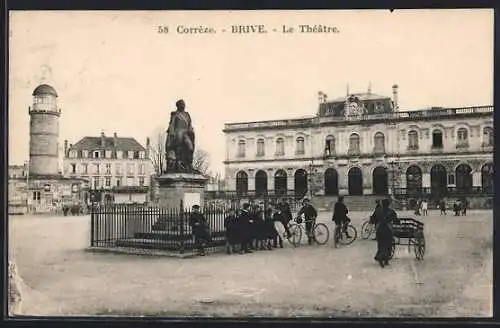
[10, 211, 493, 316]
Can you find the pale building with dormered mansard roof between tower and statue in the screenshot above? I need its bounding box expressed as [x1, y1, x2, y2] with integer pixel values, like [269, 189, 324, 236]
[63, 132, 152, 203]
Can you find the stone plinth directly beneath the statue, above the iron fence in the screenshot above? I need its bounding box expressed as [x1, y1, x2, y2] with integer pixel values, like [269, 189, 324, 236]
[157, 173, 208, 208]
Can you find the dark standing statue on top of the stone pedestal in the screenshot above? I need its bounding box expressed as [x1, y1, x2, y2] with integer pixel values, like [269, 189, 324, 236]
[165, 99, 194, 173]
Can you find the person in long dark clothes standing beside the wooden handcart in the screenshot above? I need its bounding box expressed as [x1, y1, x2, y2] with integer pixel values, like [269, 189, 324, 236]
[374, 199, 398, 267]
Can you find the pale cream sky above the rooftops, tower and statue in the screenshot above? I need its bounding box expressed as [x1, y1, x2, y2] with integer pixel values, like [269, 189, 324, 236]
[9, 9, 493, 173]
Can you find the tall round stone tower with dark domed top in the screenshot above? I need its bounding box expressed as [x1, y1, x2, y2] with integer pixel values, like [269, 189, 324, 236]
[29, 84, 61, 176]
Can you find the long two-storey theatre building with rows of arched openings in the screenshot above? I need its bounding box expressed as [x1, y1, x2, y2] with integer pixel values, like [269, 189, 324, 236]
[224, 85, 494, 198]
